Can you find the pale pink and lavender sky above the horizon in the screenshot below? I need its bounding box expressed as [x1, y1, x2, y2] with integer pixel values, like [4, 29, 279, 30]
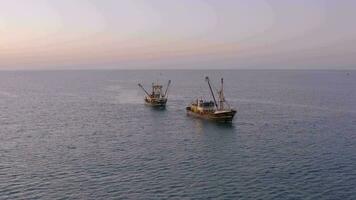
[0, 0, 356, 70]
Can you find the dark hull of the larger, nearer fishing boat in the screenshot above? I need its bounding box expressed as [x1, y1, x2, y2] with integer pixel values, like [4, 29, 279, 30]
[186, 107, 236, 122]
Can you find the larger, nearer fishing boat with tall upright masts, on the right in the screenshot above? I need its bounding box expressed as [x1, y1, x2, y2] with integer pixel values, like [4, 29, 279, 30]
[186, 77, 236, 122]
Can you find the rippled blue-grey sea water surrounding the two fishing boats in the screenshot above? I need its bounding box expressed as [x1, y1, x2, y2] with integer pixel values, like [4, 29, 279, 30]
[0, 70, 356, 200]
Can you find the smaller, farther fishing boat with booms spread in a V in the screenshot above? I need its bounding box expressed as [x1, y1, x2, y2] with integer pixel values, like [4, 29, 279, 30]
[138, 80, 171, 107]
